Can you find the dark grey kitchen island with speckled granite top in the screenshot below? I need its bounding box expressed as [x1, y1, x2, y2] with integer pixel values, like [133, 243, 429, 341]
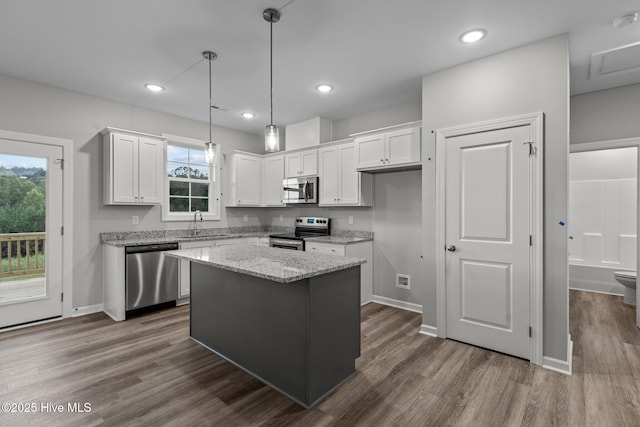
[166, 246, 365, 408]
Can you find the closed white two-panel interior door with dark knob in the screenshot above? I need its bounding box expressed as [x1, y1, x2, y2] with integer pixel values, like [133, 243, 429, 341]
[442, 126, 531, 359]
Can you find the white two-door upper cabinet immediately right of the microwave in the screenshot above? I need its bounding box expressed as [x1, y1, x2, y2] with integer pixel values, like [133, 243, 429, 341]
[318, 142, 373, 206]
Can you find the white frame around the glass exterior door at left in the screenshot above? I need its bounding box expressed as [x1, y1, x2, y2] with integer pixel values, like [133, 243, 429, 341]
[0, 129, 73, 318]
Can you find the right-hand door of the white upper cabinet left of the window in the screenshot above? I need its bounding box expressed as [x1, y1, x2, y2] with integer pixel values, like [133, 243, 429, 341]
[138, 138, 164, 204]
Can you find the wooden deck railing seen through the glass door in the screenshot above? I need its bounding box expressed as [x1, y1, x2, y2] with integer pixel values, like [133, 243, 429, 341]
[0, 233, 45, 279]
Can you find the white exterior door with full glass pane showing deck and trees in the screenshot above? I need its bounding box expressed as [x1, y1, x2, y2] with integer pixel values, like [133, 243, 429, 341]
[0, 139, 63, 328]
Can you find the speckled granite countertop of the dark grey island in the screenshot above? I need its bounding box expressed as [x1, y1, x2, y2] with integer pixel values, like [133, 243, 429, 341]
[164, 245, 366, 283]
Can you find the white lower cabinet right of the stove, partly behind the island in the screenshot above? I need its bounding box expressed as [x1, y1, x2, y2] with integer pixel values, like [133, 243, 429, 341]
[305, 240, 373, 305]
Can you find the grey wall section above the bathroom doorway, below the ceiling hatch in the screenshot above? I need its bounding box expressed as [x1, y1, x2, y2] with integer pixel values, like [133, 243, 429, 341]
[571, 84, 640, 144]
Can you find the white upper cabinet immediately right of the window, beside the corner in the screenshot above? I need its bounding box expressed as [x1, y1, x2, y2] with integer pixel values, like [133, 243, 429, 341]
[225, 153, 262, 207]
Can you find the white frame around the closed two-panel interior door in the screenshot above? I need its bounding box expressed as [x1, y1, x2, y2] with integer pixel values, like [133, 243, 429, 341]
[436, 112, 544, 366]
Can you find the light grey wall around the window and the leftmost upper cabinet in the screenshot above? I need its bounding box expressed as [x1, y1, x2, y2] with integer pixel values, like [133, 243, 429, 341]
[0, 75, 263, 307]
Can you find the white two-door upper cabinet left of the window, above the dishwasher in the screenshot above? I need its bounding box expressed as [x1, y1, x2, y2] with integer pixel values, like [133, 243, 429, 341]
[102, 128, 165, 205]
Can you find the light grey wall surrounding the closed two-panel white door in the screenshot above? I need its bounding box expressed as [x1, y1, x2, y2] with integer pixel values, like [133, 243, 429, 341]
[422, 35, 569, 361]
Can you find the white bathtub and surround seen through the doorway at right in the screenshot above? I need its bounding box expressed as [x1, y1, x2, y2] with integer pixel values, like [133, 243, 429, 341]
[569, 147, 638, 295]
